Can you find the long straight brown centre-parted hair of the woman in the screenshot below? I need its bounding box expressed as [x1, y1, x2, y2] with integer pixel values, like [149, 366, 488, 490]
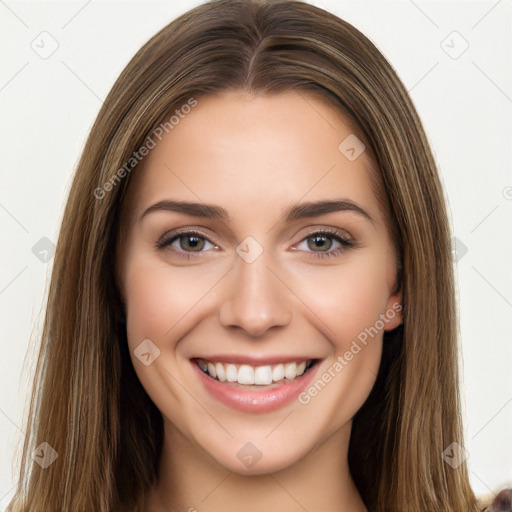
[8, 0, 484, 512]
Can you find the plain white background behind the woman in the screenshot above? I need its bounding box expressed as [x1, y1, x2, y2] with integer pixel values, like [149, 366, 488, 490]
[0, 0, 512, 510]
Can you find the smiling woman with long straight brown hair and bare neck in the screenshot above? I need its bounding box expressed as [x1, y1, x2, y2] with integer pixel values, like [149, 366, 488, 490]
[8, 0, 506, 512]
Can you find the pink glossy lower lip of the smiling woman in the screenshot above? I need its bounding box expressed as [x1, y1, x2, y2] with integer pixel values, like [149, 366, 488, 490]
[191, 361, 319, 413]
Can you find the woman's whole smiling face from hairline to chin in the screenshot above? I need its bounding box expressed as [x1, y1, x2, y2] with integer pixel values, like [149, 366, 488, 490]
[118, 92, 401, 474]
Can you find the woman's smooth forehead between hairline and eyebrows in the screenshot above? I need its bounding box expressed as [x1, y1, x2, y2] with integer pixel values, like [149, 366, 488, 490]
[123, 91, 379, 229]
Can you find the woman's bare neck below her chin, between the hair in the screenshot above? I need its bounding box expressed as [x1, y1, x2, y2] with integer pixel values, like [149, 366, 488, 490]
[145, 420, 366, 512]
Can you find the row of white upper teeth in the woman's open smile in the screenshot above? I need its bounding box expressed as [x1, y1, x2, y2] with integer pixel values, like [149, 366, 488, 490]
[197, 359, 311, 386]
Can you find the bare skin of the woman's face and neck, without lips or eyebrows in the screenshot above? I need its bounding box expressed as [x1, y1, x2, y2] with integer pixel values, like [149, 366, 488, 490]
[118, 91, 401, 512]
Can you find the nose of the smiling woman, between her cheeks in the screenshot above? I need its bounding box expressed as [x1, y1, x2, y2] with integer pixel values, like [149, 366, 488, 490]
[220, 250, 292, 338]
